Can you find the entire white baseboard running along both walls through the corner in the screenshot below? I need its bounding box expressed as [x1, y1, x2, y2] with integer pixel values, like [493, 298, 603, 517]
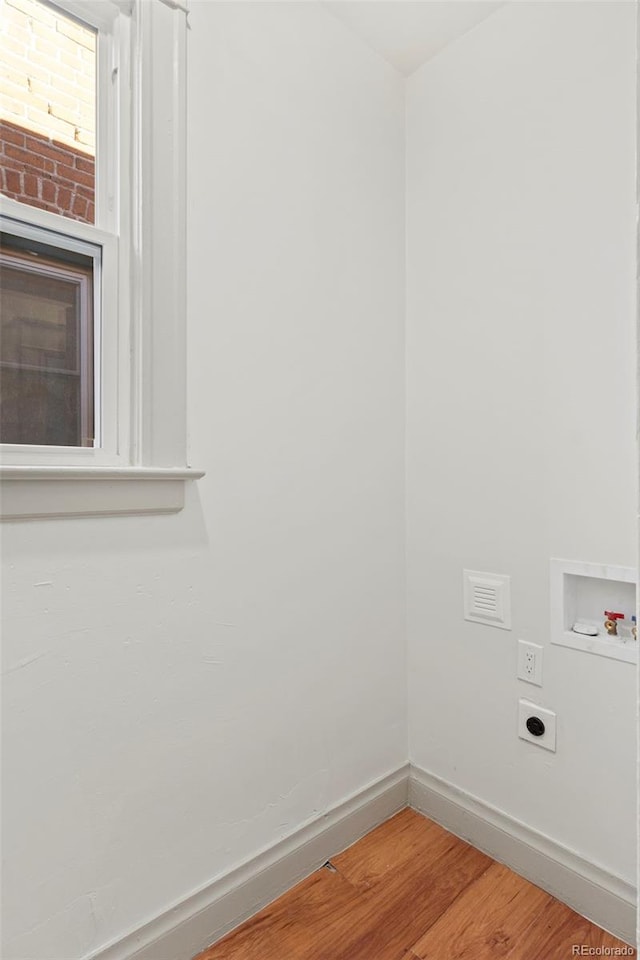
[86, 764, 636, 960]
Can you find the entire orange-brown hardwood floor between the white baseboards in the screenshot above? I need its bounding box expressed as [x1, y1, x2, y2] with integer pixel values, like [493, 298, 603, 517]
[197, 809, 636, 960]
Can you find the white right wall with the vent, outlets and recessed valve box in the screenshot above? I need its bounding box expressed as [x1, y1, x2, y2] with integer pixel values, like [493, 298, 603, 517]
[407, 2, 636, 881]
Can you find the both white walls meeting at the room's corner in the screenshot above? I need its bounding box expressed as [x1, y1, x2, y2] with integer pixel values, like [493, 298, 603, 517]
[3, 0, 635, 960]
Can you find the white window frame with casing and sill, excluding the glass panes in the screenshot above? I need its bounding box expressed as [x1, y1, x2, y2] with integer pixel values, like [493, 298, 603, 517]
[0, 0, 203, 520]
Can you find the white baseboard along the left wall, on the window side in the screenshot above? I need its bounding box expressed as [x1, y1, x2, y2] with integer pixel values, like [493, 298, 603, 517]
[87, 764, 409, 960]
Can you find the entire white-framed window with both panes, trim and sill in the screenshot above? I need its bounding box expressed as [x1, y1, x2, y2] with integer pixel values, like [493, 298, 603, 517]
[0, 0, 201, 519]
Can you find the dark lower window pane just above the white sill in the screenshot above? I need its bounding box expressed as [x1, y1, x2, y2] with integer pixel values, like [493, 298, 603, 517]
[0, 243, 94, 447]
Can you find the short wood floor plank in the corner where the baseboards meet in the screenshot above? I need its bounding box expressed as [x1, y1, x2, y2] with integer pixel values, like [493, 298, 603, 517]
[331, 807, 462, 888]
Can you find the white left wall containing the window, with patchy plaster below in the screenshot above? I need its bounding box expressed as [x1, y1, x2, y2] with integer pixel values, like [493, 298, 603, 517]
[3, 2, 407, 960]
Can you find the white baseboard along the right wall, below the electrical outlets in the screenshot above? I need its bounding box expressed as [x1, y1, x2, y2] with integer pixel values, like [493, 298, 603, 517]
[409, 765, 636, 944]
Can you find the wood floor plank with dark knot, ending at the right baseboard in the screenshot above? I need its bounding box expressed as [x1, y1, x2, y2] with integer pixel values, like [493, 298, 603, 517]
[411, 863, 553, 960]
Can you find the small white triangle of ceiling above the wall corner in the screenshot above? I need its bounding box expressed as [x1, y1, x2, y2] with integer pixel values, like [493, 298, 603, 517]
[324, 0, 505, 76]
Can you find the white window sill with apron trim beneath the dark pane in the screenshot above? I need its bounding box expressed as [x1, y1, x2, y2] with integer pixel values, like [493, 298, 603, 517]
[0, 466, 204, 520]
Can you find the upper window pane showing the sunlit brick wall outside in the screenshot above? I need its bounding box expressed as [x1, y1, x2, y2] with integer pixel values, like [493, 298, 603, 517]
[0, 0, 96, 223]
